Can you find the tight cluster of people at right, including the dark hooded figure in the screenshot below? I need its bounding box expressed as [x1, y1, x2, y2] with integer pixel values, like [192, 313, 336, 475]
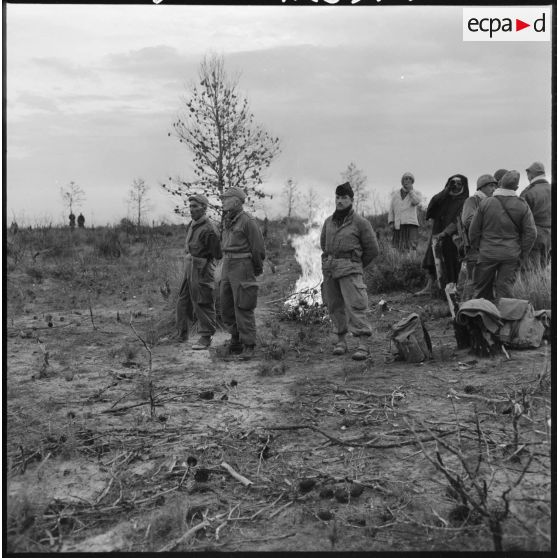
[418, 162, 552, 301]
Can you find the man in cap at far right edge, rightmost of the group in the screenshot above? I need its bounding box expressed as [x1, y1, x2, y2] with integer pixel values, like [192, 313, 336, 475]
[520, 161, 552, 267]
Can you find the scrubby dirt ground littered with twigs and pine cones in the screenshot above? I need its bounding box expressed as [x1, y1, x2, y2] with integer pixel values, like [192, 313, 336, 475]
[5, 229, 552, 552]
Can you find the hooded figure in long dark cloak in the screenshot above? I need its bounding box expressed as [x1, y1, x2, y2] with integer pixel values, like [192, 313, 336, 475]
[417, 174, 469, 294]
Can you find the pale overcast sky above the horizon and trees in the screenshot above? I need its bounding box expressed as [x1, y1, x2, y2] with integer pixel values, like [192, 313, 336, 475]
[5, 2, 552, 225]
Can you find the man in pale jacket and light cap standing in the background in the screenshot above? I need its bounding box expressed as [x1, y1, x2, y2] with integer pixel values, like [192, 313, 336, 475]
[388, 172, 420, 250]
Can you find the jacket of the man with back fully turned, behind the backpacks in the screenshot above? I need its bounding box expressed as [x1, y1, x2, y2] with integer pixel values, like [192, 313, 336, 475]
[469, 190, 537, 262]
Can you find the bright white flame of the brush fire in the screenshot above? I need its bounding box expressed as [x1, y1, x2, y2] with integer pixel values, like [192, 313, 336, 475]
[285, 203, 331, 307]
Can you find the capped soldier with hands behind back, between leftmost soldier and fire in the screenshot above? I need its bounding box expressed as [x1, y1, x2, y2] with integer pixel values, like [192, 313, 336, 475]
[220, 187, 265, 358]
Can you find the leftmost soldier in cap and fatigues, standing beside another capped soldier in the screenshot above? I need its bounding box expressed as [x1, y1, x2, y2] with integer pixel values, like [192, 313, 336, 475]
[176, 194, 222, 350]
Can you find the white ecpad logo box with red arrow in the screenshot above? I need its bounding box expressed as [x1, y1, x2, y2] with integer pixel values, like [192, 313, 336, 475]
[463, 6, 552, 41]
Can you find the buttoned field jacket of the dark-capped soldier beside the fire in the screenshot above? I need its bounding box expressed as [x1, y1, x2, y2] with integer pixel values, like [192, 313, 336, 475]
[320, 211, 379, 279]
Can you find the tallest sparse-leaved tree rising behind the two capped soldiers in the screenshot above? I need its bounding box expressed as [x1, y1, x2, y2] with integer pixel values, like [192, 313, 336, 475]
[161, 55, 280, 214]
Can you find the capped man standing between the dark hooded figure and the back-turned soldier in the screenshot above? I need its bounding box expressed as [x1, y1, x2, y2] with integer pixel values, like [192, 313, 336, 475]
[457, 175, 498, 301]
